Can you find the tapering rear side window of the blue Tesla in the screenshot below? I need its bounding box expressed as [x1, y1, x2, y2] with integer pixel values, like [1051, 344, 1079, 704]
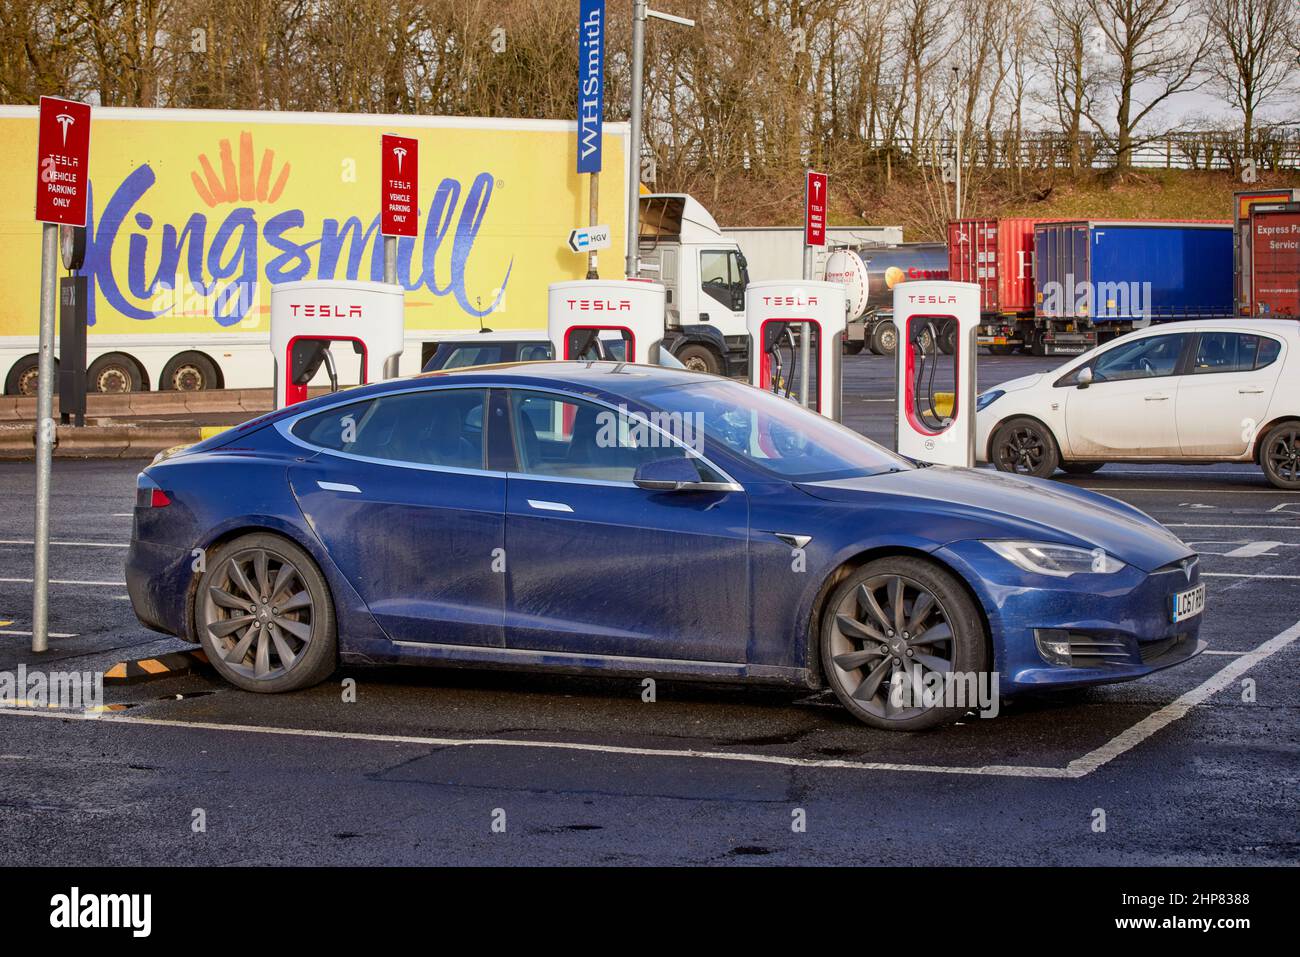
[293, 389, 486, 468]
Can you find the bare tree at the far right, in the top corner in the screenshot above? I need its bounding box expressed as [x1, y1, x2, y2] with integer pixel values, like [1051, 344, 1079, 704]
[1204, 0, 1296, 156]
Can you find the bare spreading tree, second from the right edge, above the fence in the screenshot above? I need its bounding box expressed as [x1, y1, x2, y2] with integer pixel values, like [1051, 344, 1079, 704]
[1087, 0, 1209, 169]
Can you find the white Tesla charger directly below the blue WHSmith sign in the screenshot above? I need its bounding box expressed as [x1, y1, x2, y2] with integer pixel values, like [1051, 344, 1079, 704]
[546, 280, 664, 364]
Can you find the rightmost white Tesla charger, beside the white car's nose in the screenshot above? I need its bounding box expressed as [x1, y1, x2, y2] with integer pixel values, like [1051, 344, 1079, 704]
[893, 280, 980, 468]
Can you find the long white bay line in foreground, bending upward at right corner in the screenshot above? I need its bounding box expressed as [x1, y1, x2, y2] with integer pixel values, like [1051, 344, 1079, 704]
[0, 622, 1300, 779]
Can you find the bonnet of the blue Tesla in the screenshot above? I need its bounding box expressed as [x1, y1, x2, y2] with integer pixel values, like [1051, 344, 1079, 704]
[800, 465, 1193, 571]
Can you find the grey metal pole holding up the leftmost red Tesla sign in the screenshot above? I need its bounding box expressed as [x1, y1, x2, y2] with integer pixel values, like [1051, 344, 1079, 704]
[31, 222, 59, 651]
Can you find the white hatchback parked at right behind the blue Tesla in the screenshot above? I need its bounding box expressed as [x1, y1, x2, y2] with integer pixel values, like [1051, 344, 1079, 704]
[975, 319, 1300, 489]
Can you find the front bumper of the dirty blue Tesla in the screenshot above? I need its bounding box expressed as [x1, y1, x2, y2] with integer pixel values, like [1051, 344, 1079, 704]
[936, 541, 1205, 694]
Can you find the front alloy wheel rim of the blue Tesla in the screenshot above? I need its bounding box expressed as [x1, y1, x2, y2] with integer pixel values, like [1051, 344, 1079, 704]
[831, 575, 954, 720]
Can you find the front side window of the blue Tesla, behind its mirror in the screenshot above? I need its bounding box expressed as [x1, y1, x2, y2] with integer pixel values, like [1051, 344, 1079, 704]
[511, 391, 727, 482]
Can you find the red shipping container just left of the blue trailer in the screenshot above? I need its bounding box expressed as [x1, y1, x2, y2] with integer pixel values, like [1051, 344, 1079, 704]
[948, 216, 1050, 316]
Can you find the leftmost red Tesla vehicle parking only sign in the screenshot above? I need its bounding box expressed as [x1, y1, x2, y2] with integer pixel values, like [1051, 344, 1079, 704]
[36, 96, 90, 226]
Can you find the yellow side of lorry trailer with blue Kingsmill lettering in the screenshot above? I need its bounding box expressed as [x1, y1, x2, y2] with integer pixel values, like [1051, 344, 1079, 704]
[0, 107, 627, 338]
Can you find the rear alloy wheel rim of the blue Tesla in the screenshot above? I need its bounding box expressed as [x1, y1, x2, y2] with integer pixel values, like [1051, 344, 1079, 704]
[203, 549, 316, 681]
